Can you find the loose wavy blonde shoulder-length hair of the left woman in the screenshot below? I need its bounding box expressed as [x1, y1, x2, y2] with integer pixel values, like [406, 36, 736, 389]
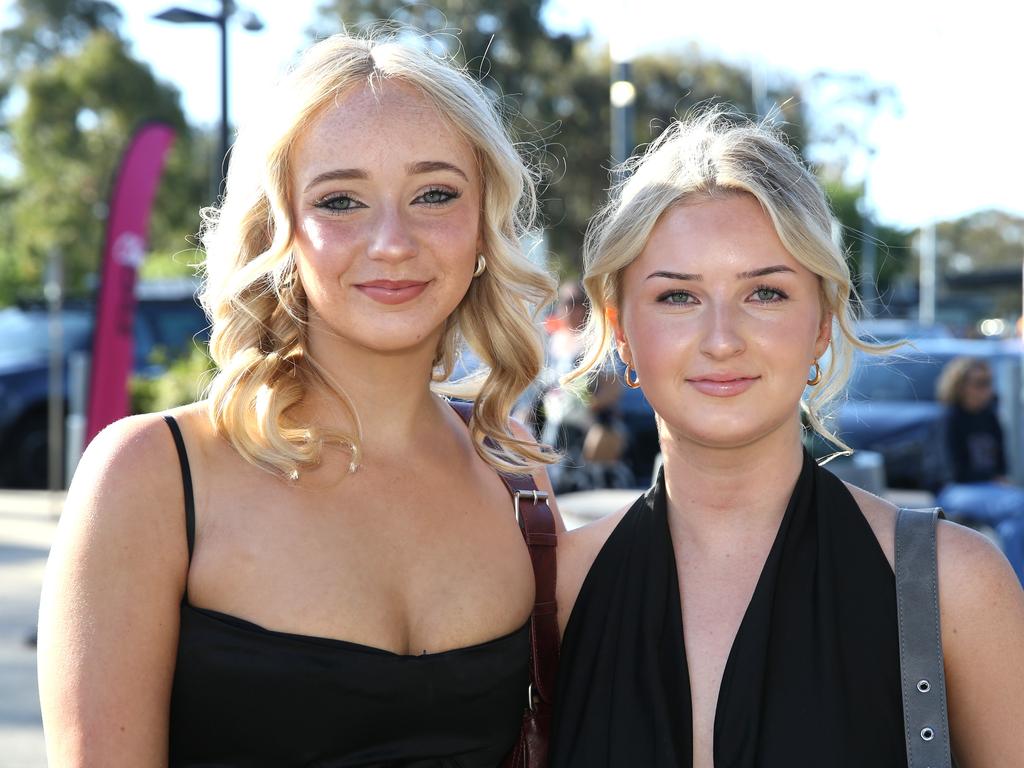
[200, 33, 554, 479]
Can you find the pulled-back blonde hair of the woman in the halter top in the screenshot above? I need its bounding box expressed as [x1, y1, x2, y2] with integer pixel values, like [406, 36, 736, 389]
[565, 108, 898, 451]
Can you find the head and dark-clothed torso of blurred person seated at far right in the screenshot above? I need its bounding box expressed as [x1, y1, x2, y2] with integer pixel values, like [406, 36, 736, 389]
[938, 357, 1007, 482]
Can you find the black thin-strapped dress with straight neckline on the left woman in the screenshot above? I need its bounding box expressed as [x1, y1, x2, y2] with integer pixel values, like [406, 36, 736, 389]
[166, 417, 529, 768]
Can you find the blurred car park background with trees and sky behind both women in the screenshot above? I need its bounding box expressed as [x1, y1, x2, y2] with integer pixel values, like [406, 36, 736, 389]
[0, 0, 1024, 768]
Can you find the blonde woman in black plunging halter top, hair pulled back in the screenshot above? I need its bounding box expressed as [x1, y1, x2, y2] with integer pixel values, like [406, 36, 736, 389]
[552, 112, 1024, 768]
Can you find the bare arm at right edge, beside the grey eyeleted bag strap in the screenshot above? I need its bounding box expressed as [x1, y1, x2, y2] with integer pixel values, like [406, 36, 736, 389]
[938, 522, 1024, 768]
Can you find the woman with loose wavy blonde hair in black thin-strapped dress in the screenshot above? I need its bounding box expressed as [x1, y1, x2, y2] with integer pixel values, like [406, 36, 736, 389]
[39, 35, 557, 768]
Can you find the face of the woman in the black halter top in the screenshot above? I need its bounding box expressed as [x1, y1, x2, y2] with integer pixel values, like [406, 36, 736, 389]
[616, 195, 831, 447]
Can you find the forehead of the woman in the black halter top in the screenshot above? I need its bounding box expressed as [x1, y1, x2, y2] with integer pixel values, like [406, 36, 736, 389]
[631, 193, 810, 274]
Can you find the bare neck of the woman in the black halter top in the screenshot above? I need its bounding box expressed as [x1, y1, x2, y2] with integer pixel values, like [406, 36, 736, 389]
[662, 422, 803, 547]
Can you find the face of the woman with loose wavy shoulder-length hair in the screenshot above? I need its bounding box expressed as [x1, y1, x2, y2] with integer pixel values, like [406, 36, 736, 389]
[291, 82, 482, 362]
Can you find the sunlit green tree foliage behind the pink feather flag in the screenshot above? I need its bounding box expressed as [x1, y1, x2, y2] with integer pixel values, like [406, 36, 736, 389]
[0, 6, 208, 303]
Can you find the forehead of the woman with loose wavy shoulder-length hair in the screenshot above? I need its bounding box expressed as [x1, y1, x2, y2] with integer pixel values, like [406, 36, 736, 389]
[292, 81, 476, 182]
